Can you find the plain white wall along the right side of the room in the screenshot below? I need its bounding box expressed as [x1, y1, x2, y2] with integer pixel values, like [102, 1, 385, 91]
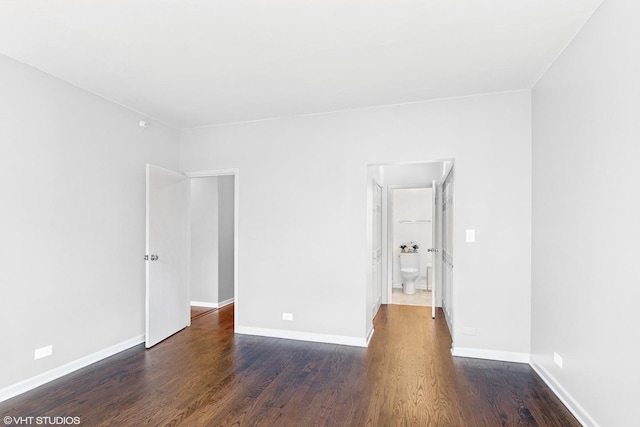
[532, 0, 640, 426]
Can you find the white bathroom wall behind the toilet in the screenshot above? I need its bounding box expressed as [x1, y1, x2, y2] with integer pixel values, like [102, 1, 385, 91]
[392, 188, 433, 289]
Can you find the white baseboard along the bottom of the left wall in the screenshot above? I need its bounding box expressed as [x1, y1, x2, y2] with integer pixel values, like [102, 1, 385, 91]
[0, 335, 144, 402]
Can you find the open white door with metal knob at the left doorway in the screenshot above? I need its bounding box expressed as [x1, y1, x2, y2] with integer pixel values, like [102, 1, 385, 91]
[145, 165, 190, 348]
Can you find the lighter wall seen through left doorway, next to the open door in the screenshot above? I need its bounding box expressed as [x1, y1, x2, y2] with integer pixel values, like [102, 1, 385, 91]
[189, 176, 219, 304]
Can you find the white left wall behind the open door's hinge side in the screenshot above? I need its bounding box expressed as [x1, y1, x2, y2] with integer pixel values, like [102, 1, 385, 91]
[0, 55, 179, 394]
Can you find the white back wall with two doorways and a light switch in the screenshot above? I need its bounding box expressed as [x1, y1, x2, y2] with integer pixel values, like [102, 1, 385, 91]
[181, 91, 531, 354]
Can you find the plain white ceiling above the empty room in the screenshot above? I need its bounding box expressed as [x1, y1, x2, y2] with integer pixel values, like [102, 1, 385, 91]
[0, 0, 602, 128]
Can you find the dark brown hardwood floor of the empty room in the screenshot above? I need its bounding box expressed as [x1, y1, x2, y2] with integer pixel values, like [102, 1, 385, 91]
[0, 305, 580, 427]
